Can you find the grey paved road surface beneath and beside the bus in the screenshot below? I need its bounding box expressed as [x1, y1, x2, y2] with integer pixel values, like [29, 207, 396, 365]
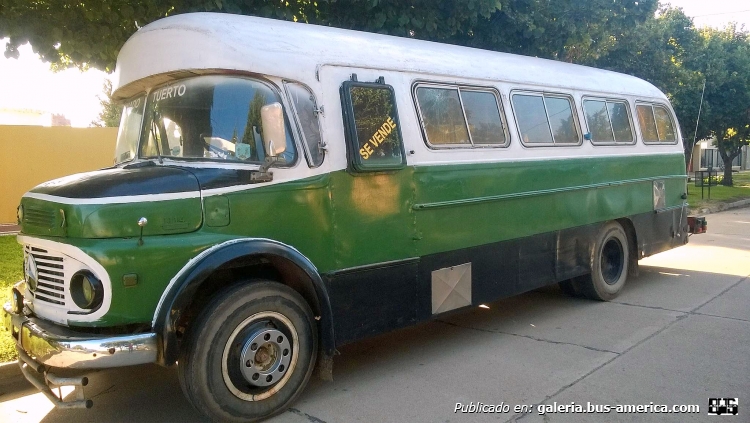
[0, 209, 750, 423]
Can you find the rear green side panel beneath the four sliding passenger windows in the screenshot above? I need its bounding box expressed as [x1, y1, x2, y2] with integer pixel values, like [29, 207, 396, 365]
[414, 155, 686, 256]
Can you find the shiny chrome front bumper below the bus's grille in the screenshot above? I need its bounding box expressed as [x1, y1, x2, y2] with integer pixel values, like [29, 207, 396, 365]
[3, 303, 158, 369]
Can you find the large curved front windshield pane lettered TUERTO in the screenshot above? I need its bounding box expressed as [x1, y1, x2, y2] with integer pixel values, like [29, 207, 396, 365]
[140, 76, 296, 164]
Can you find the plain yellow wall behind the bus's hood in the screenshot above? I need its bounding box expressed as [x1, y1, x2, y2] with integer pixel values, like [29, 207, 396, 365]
[0, 125, 117, 223]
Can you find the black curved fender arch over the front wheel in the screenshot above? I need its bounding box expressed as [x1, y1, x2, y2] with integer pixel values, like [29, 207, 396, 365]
[152, 238, 335, 366]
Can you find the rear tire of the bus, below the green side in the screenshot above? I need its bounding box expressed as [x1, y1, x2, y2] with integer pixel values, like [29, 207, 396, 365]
[573, 222, 630, 301]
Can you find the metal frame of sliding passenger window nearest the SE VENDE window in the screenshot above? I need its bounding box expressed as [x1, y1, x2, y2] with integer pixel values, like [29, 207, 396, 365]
[411, 80, 511, 150]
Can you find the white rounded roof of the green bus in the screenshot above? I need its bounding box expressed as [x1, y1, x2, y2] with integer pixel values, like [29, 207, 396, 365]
[113, 13, 666, 99]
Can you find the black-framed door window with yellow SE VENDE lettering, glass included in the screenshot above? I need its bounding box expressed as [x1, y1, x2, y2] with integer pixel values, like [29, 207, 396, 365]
[341, 81, 406, 172]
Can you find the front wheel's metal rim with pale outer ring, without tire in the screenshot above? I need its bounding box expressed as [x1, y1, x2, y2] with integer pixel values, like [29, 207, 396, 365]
[221, 312, 299, 401]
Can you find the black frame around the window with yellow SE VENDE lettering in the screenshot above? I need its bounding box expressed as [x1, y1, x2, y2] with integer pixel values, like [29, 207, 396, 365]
[339, 80, 407, 173]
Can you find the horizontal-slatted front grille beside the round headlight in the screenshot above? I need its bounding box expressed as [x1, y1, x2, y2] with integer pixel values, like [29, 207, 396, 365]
[24, 245, 67, 306]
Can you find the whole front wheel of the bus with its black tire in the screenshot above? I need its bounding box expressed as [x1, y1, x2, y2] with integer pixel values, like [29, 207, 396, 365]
[177, 281, 318, 422]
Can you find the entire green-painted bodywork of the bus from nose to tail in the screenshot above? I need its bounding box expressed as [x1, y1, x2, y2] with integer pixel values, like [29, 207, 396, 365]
[17, 154, 686, 326]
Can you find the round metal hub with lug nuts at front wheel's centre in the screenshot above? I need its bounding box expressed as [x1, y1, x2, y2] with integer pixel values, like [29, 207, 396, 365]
[239, 328, 292, 387]
